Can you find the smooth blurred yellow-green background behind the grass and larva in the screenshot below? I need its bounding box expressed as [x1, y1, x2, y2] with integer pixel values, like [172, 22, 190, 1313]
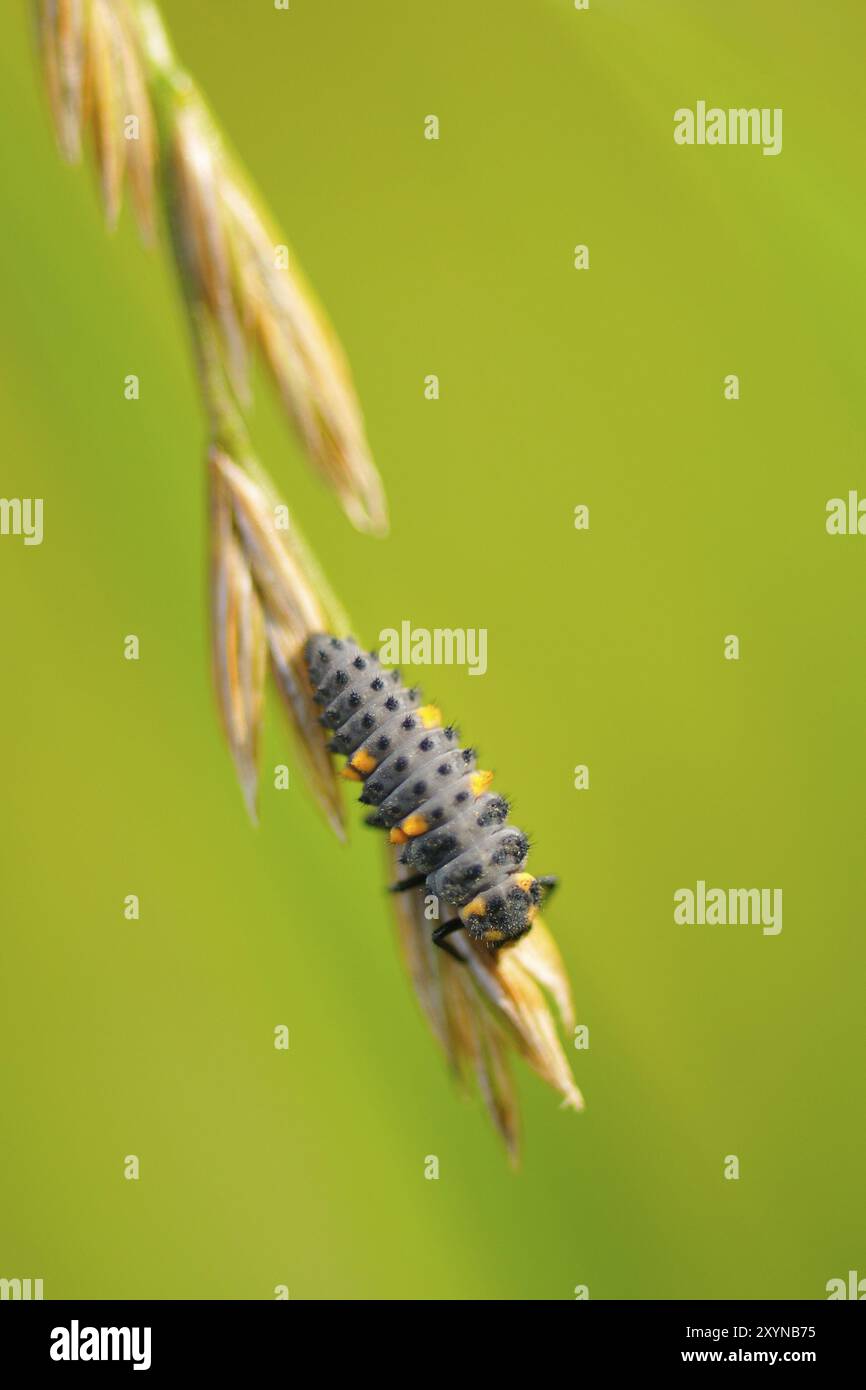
[0, 0, 866, 1300]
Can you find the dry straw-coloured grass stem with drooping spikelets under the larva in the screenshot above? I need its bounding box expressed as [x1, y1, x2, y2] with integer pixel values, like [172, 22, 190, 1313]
[35, 0, 582, 1159]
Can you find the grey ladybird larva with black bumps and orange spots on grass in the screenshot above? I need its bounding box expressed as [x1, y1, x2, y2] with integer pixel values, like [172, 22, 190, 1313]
[306, 634, 552, 949]
